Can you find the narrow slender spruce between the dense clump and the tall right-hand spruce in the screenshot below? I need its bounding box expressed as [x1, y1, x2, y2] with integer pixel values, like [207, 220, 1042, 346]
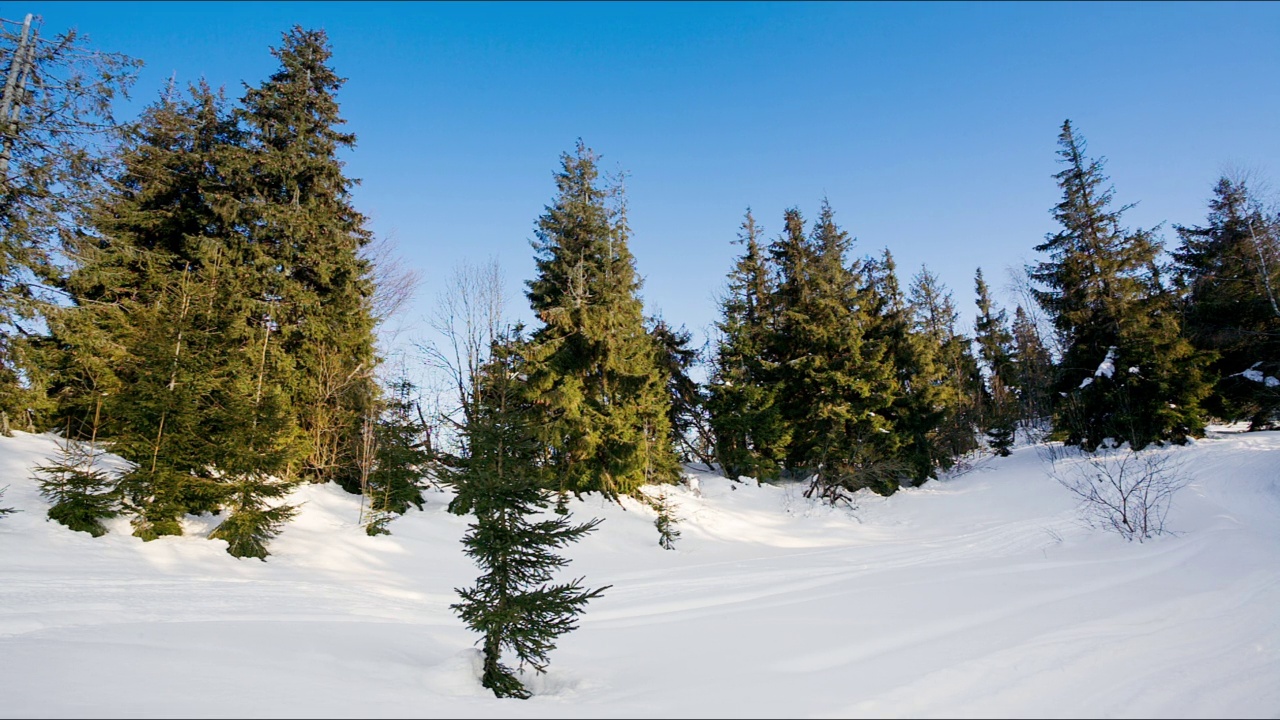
[974, 268, 1018, 457]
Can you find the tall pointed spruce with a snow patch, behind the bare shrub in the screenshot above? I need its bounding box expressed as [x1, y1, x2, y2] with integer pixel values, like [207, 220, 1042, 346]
[1032, 120, 1208, 450]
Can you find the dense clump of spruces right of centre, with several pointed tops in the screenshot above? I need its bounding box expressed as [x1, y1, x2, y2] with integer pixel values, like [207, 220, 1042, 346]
[708, 202, 983, 491]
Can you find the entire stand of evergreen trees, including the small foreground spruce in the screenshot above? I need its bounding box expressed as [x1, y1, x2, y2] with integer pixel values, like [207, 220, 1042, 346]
[0, 19, 1280, 697]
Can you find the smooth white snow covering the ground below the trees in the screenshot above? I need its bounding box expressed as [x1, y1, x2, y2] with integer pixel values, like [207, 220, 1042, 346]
[0, 432, 1280, 717]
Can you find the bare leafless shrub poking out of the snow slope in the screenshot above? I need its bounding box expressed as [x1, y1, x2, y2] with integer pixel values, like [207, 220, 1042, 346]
[1041, 445, 1189, 542]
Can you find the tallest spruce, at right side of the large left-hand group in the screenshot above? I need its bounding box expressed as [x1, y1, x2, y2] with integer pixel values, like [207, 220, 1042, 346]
[236, 27, 378, 492]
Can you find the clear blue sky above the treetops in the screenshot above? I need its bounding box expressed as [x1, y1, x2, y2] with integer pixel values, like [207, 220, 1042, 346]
[12, 3, 1280, 356]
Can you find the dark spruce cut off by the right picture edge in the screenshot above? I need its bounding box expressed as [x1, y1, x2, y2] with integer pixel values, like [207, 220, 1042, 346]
[1174, 177, 1280, 429]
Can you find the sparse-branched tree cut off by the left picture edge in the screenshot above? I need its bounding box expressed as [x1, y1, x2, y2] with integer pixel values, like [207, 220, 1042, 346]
[0, 17, 142, 429]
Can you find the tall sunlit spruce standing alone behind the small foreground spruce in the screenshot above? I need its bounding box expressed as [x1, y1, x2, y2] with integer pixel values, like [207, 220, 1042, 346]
[527, 140, 680, 497]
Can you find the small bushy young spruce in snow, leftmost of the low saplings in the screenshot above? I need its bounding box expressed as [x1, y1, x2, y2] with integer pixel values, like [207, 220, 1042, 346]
[35, 427, 119, 537]
